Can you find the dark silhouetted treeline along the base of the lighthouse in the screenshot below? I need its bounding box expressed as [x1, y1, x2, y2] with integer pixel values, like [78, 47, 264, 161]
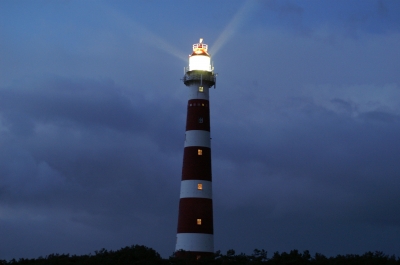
[0, 245, 400, 265]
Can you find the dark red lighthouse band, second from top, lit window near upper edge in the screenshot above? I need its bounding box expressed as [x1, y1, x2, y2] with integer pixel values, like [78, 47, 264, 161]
[182, 146, 212, 181]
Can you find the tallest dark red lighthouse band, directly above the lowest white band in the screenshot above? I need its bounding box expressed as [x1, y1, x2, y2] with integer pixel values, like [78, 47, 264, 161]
[178, 198, 214, 234]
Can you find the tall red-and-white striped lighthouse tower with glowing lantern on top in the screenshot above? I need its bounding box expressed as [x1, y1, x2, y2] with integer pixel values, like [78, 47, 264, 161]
[175, 39, 216, 258]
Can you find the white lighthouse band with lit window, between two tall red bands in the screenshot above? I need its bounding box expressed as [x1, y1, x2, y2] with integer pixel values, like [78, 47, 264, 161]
[180, 180, 212, 199]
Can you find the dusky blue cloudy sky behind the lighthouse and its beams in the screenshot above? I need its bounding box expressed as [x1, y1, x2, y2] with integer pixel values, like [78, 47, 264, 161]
[0, 0, 400, 260]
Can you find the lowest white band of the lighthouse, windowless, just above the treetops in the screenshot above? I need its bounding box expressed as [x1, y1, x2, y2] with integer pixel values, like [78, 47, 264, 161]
[175, 233, 214, 252]
